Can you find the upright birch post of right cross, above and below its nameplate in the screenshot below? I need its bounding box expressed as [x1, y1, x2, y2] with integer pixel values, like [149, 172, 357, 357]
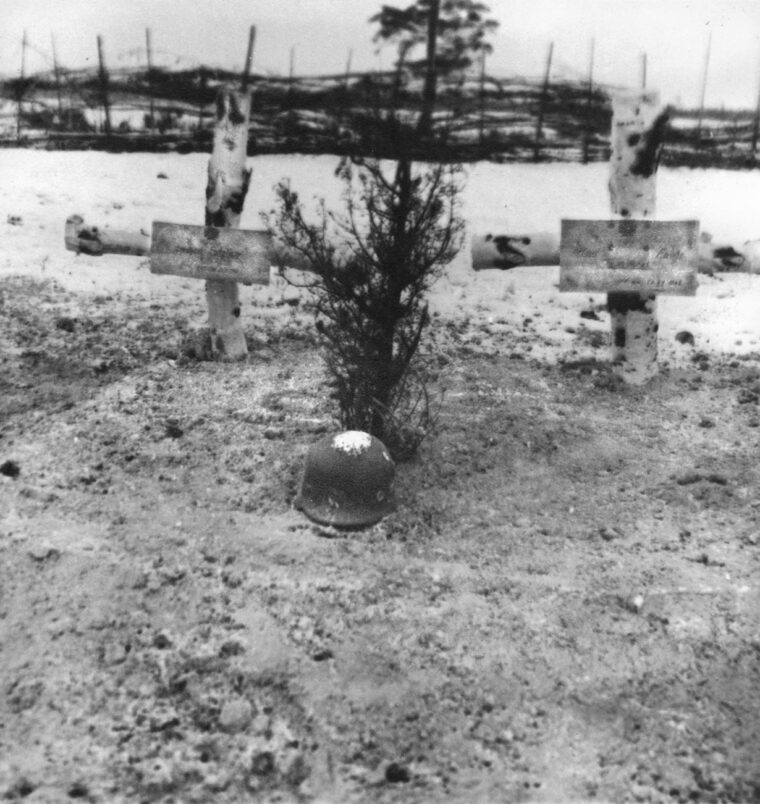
[607, 92, 667, 385]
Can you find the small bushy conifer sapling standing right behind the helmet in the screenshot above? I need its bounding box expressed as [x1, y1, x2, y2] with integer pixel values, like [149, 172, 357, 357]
[266, 140, 464, 460]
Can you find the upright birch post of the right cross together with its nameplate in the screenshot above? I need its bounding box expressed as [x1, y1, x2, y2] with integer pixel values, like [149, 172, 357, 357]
[560, 92, 699, 385]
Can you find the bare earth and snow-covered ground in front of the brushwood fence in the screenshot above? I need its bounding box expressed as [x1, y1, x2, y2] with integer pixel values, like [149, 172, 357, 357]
[0, 138, 760, 802]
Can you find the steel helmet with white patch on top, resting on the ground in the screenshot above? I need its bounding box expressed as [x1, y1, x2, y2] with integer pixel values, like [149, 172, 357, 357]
[295, 430, 396, 528]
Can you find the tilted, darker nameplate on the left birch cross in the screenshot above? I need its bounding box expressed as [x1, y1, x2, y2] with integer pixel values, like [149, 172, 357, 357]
[150, 221, 272, 285]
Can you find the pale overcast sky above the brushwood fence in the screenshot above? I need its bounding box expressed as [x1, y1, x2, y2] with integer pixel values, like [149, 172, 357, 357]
[0, 0, 760, 108]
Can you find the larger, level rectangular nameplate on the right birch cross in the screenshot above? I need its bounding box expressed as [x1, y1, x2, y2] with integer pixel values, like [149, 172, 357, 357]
[559, 220, 699, 296]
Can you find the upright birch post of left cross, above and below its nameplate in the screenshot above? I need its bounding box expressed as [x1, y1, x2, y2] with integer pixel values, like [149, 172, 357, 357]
[206, 87, 251, 360]
